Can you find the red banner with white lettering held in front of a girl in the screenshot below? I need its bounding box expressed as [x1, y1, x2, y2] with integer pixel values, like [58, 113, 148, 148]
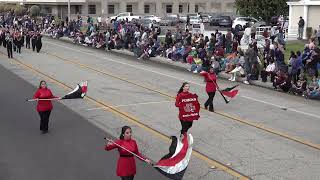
[179, 94, 200, 121]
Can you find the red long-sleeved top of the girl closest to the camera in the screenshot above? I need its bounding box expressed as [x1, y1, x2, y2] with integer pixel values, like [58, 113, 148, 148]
[105, 139, 145, 177]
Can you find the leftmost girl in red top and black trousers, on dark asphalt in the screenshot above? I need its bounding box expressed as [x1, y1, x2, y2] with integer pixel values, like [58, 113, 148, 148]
[33, 81, 61, 134]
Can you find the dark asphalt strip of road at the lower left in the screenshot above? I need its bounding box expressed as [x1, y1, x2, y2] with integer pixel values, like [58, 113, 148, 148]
[0, 64, 166, 180]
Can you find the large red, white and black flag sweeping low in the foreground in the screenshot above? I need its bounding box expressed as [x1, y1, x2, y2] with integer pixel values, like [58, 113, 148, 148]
[154, 133, 193, 180]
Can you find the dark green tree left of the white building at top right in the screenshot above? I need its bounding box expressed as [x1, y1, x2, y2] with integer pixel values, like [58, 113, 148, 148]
[235, 0, 289, 22]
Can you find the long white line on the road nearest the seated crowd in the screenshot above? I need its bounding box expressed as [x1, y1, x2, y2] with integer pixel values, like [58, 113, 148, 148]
[46, 42, 320, 119]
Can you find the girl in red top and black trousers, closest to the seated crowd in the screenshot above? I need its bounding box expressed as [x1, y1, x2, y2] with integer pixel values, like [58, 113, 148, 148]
[200, 67, 219, 112]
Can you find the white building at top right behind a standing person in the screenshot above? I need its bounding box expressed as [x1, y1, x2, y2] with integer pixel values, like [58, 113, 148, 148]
[287, 0, 320, 39]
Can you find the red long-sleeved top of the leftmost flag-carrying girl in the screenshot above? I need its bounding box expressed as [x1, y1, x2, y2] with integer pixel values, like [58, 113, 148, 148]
[33, 88, 56, 112]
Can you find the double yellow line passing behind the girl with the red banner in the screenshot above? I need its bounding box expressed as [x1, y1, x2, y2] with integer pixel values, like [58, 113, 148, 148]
[45, 52, 320, 150]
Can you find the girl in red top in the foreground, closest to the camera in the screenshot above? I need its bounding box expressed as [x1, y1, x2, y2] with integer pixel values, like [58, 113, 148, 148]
[105, 126, 151, 180]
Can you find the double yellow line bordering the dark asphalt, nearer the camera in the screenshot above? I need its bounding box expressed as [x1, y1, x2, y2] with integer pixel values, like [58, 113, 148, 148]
[0, 51, 251, 180]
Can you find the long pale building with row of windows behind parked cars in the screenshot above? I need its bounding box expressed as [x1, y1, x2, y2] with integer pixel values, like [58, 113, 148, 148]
[1, 0, 235, 17]
